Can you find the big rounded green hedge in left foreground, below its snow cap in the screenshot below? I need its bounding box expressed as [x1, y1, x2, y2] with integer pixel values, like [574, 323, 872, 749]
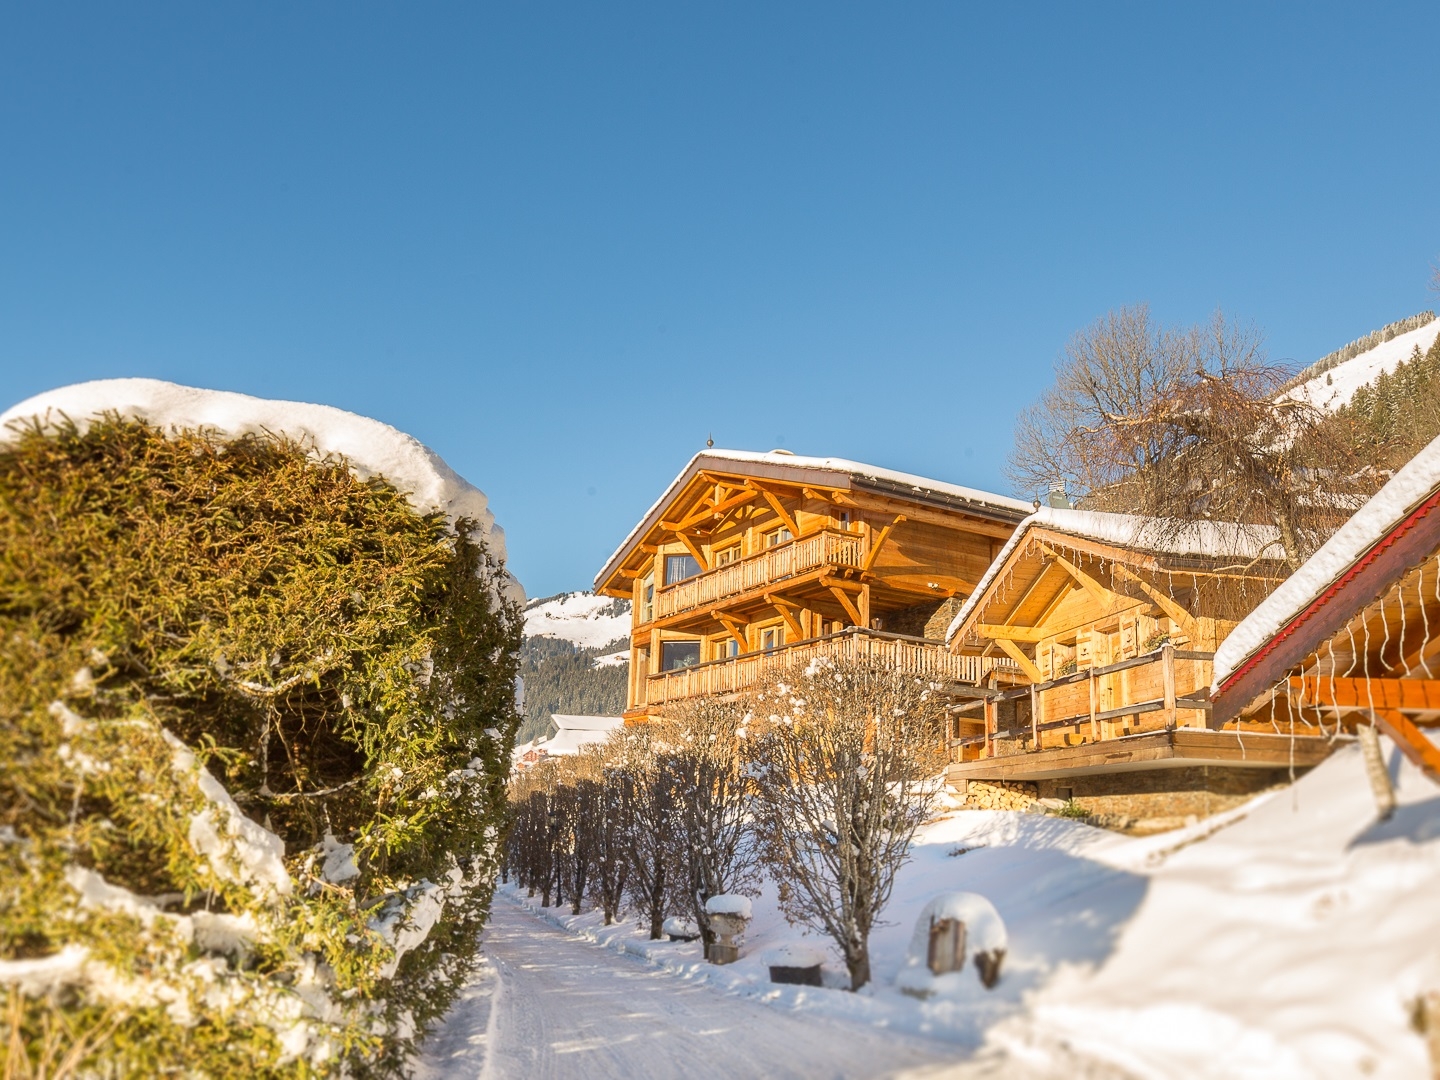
[0, 416, 520, 1077]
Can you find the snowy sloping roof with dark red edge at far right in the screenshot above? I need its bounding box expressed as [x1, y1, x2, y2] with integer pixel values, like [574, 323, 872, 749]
[1215, 438, 1440, 707]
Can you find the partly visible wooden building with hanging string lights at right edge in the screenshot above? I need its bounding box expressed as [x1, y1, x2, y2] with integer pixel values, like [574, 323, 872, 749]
[1211, 439, 1440, 782]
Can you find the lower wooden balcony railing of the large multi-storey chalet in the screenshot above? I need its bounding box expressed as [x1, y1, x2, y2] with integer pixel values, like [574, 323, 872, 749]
[634, 626, 1014, 707]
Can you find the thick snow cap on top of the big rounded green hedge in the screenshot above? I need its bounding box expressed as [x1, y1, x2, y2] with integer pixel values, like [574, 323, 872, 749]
[0, 379, 524, 602]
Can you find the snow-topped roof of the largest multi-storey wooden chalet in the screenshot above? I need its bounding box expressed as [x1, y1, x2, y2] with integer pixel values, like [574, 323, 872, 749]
[595, 448, 1031, 589]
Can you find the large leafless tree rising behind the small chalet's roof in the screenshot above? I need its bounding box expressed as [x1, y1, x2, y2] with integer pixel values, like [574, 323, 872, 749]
[1009, 307, 1384, 569]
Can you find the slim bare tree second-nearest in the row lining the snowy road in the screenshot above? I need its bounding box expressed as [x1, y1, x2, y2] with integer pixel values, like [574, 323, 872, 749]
[657, 697, 759, 948]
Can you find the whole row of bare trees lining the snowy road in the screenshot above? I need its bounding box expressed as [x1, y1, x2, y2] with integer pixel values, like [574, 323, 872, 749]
[507, 661, 945, 988]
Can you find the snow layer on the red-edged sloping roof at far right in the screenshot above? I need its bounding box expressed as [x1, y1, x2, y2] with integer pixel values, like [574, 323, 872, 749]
[1214, 429, 1440, 688]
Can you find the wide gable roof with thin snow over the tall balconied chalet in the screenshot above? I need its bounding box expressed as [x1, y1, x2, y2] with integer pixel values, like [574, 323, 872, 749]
[595, 449, 1031, 590]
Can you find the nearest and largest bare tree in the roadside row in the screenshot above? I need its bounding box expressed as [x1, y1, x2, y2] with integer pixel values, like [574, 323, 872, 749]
[749, 661, 945, 989]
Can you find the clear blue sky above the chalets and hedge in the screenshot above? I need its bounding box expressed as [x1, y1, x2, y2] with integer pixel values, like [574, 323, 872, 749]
[0, 3, 1440, 596]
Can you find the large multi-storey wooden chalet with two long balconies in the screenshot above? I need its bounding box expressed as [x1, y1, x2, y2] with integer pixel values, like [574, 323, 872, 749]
[595, 449, 1030, 720]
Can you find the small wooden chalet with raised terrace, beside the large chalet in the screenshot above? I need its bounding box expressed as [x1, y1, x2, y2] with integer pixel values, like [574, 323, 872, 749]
[948, 507, 1328, 814]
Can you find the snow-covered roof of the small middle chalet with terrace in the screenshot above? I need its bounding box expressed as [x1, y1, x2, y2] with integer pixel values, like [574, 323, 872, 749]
[945, 507, 1284, 641]
